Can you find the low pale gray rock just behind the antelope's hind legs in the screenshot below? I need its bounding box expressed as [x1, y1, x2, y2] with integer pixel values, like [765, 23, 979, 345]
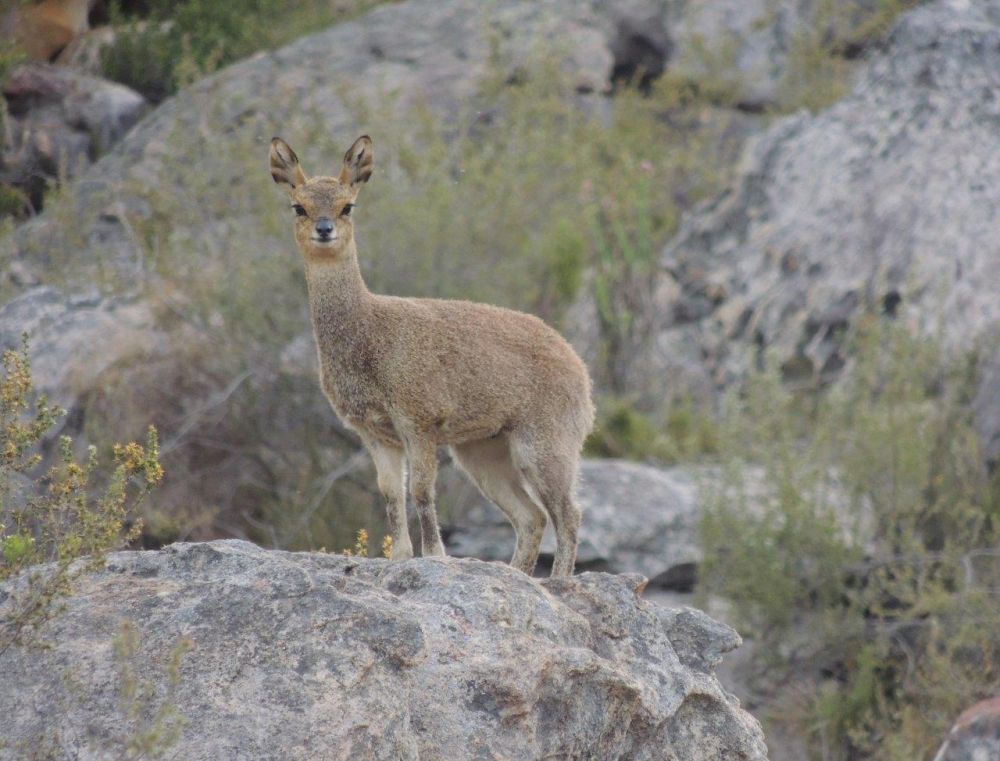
[446, 460, 707, 591]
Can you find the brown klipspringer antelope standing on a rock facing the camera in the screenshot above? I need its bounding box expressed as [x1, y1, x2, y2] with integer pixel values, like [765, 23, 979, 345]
[270, 136, 594, 576]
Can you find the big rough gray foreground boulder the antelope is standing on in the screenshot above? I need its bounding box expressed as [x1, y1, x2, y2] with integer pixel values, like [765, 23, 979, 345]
[0, 540, 766, 761]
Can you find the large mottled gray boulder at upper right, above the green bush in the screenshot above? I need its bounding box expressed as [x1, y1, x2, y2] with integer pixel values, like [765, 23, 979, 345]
[592, 0, 1000, 396]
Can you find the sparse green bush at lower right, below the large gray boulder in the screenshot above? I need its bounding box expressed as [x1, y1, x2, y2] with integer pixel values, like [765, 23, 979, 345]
[700, 317, 1000, 761]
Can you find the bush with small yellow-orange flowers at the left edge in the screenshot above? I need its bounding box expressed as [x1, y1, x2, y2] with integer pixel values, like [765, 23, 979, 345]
[0, 339, 163, 652]
